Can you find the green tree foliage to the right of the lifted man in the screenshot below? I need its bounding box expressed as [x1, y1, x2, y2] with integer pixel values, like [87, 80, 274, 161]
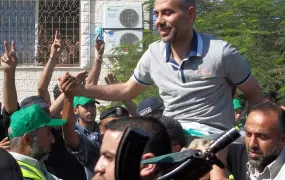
[195, 0, 285, 101]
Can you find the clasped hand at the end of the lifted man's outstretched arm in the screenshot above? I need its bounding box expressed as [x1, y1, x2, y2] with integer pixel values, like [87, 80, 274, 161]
[58, 72, 80, 98]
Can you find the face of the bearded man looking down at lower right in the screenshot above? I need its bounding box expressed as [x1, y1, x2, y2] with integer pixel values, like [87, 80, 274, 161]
[245, 111, 284, 169]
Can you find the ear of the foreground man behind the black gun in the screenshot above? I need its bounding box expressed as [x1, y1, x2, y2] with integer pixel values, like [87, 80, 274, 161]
[140, 153, 157, 179]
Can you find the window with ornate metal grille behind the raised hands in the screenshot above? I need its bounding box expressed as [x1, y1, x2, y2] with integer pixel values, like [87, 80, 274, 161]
[0, 0, 80, 66]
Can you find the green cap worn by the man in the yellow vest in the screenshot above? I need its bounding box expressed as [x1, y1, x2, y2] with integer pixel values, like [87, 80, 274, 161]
[9, 104, 66, 138]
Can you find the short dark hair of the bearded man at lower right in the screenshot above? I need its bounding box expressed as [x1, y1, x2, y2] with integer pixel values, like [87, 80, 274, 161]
[250, 102, 285, 133]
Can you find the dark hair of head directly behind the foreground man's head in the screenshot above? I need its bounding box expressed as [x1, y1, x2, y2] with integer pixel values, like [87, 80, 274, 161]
[160, 116, 185, 147]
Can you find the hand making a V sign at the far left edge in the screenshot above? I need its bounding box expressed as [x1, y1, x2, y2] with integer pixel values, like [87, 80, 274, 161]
[1, 41, 18, 72]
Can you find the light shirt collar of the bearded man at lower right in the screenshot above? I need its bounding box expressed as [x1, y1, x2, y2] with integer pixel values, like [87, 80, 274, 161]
[246, 147, 285, 179]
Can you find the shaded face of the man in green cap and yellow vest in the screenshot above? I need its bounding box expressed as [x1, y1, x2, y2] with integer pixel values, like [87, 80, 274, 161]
[31, 126, 55, 160]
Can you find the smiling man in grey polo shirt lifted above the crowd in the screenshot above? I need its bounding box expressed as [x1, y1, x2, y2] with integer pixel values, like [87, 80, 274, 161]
[59, 0, 262, 133]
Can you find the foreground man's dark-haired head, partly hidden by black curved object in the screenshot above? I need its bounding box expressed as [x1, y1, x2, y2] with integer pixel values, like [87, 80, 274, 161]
[93, 117, 171, 180]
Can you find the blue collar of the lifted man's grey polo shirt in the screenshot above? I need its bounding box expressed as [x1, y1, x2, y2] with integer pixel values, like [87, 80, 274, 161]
[163, 30, 203, 62]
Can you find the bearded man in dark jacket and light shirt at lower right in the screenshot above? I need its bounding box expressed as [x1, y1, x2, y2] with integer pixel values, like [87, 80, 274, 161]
[213, 102, 285, 180]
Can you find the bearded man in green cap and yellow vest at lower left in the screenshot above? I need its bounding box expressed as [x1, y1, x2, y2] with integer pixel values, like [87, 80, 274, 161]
[8, 104, 66, 180]
